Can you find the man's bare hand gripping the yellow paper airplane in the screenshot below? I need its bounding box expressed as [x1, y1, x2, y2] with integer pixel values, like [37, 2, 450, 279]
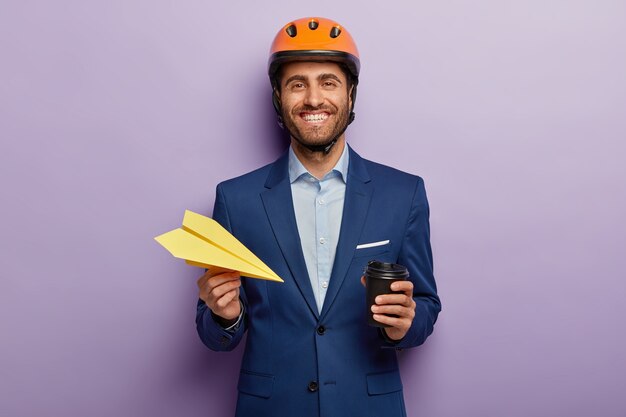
[198, 269, 241, 322]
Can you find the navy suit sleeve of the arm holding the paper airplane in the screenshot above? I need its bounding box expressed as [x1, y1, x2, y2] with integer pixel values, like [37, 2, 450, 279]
[196, 185, 247, 351]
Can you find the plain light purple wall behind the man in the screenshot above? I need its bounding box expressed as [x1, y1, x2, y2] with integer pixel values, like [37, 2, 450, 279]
[0, 0, 626, 417]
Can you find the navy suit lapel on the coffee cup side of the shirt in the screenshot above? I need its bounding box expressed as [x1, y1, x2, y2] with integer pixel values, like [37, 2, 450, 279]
[320, 148, 372, 319]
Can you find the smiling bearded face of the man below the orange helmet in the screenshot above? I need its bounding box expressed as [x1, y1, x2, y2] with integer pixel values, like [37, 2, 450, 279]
[279, 61, 352, 152]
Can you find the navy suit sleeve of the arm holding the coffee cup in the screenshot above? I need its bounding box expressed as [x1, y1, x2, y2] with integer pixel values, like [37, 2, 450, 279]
[387, 178, 441, 348]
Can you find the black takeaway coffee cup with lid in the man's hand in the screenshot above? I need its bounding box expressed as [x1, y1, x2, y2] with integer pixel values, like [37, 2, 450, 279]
[364, 261, 409, 327]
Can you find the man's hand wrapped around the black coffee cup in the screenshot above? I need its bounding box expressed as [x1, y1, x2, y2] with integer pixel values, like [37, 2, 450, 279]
[361, 277, 416, 340]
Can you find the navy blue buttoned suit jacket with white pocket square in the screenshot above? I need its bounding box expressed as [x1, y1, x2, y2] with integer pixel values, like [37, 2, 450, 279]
[197, 145, 440, 417]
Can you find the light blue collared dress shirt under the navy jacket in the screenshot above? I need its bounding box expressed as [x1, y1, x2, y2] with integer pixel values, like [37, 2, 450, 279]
[289, 145, 349, 312]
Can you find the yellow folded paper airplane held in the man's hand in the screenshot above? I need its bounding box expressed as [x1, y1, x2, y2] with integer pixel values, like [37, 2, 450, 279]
[154, 210, 284, 282]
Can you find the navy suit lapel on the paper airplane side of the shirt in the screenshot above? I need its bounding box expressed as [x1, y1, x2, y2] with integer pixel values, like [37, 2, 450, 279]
[261, 154, 319, 318]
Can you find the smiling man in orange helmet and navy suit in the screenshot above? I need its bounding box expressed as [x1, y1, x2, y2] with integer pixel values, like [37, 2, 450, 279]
[196, 18, 440, 417]
